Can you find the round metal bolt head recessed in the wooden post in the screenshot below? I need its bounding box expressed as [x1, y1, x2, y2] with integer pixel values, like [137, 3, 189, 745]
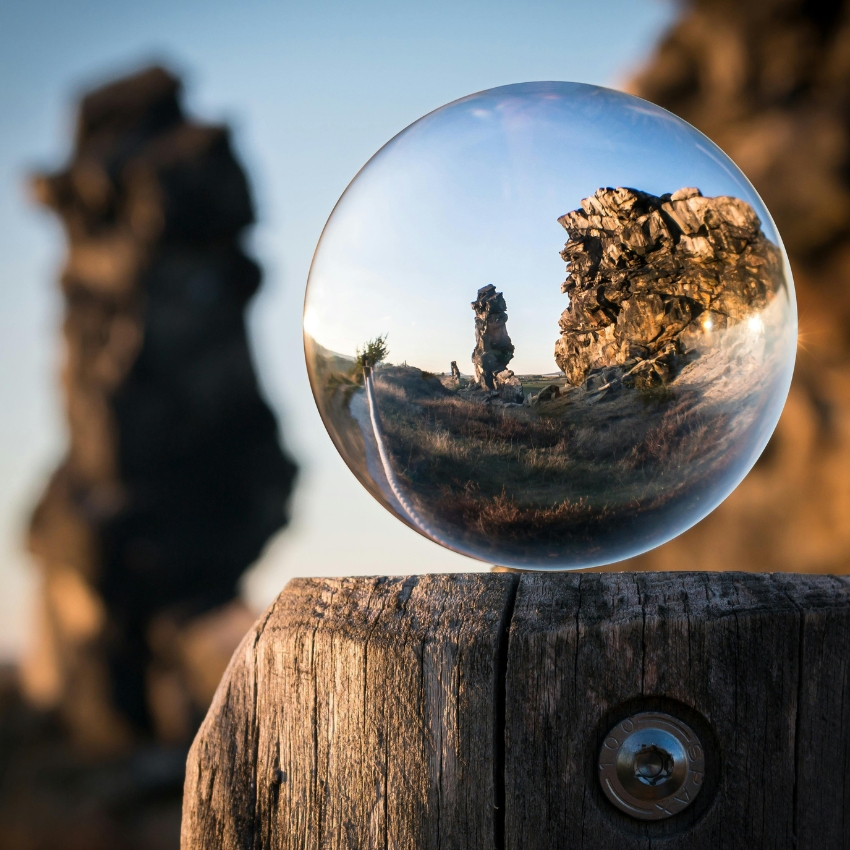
[599, 711, 705, 820]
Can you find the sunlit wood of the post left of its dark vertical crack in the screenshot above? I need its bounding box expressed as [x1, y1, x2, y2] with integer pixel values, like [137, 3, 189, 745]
[183, 574, 517, 850]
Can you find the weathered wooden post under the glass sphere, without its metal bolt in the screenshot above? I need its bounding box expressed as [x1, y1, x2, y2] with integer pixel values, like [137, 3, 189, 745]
[183, 573, 850, 850]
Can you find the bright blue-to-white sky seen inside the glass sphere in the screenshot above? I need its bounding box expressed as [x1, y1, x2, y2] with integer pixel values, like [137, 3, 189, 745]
[305, 83, 777, 374]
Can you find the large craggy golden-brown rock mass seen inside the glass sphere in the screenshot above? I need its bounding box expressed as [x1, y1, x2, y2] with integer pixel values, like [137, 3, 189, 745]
[555, 188, 782, 386]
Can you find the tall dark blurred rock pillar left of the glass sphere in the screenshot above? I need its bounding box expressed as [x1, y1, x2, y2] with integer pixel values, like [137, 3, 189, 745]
[0, 67, 296, 848]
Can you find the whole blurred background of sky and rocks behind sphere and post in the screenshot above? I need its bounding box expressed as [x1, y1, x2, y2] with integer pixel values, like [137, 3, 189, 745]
[0, 0, 850, 850]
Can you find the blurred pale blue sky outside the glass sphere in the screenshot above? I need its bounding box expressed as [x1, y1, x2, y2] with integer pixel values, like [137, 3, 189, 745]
[0, 0, 674, 656]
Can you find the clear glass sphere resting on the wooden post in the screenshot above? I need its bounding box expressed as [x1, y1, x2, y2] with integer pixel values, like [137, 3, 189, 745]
[304, 82, 797, 569]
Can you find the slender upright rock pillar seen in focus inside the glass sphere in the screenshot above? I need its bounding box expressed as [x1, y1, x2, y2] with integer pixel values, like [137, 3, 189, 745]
[472, 284, 524, 404]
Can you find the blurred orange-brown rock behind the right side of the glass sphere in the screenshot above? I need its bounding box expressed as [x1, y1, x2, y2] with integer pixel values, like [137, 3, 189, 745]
[615, 0, 850, 573]
